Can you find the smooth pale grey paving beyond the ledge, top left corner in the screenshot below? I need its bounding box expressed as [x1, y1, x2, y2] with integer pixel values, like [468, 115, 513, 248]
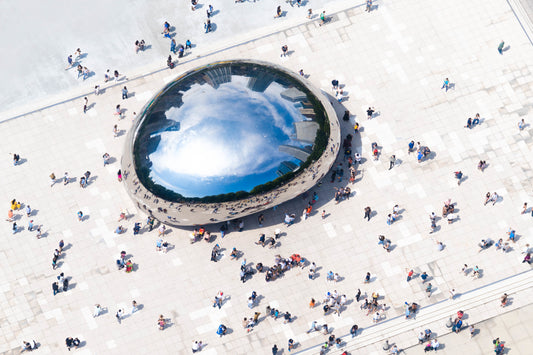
[0, 0, 353, 117]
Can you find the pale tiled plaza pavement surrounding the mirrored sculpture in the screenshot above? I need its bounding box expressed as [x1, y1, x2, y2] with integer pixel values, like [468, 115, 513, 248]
[0, 0, 533, 354]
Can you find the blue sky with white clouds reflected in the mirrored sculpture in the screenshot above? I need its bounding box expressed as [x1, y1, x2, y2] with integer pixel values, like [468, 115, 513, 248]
[142, 75, 316, 197]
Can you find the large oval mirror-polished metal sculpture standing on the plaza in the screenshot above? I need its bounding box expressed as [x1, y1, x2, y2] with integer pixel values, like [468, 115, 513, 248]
[121, 60, 340, 226]
